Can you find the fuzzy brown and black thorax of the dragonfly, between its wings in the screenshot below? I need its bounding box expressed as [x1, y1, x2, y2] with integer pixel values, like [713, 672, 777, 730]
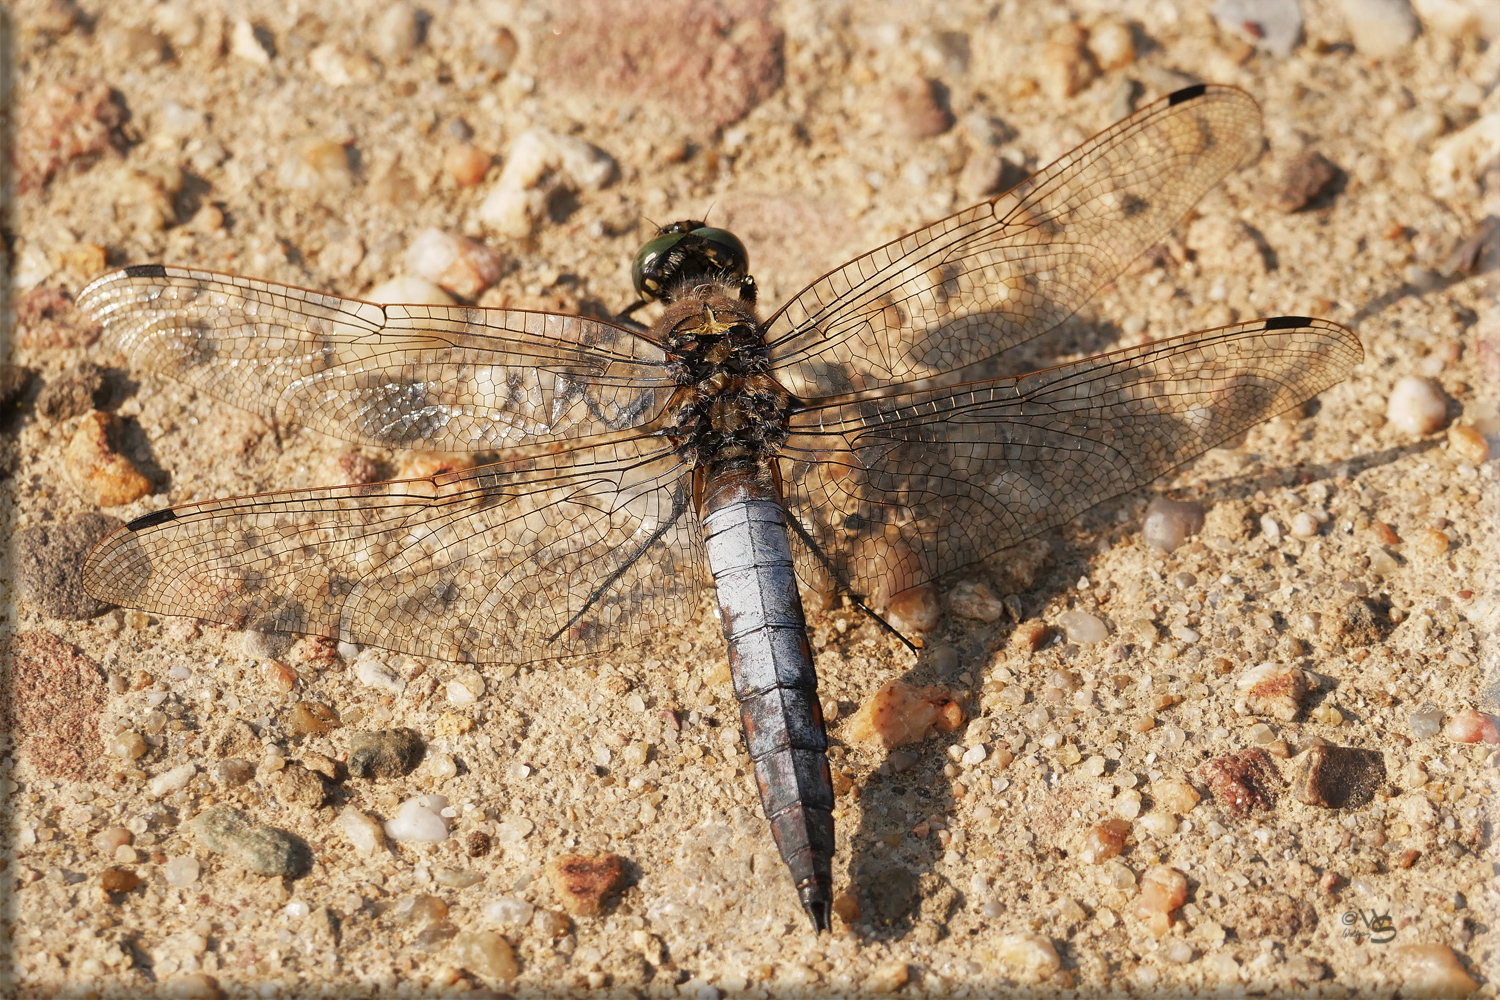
[654, 282, 791, 466]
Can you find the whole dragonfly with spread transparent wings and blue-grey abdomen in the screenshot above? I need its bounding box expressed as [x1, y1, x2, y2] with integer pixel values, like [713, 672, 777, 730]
[78, 84, 1364, 931]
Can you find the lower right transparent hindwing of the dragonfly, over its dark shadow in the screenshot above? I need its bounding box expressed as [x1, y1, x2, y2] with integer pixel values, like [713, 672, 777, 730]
[782, 316, 1364, 601]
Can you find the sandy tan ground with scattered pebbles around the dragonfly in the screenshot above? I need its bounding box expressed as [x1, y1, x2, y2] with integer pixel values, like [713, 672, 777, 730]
[0, 0, 1500, 997]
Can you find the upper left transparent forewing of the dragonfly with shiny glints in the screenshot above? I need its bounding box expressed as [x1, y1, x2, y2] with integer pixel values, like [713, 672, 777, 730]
[78, 264, 672, 451]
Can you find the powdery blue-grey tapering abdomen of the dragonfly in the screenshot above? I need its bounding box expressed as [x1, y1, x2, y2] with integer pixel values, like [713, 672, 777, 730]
[704, 472, 834, 931]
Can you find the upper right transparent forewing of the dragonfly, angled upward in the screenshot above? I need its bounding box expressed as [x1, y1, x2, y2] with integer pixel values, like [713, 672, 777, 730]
[767, 87, 1260, 400]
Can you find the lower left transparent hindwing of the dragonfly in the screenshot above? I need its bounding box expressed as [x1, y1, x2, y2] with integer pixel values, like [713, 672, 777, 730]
[84, 438, 702, 663]
